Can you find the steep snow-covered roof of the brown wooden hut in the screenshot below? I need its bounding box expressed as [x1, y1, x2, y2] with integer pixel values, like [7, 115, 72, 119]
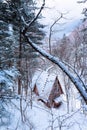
[34, 71, 59, 100]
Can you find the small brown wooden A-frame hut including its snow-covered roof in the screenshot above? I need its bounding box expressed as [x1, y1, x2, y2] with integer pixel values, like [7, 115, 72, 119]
[33, 72, 63, 108]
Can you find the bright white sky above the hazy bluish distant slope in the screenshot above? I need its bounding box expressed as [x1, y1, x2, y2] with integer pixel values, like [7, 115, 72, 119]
[43, 0, 85, 19]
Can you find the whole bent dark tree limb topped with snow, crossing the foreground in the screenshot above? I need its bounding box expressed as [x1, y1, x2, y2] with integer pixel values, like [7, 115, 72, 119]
[21, 0, 87, 103]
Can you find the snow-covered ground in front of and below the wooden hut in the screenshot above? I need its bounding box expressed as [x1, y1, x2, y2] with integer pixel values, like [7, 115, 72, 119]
[0, 95, 87, 130]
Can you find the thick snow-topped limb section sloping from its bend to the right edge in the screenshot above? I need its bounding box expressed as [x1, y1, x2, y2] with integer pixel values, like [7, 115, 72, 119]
[25, 36, 87, 103]
